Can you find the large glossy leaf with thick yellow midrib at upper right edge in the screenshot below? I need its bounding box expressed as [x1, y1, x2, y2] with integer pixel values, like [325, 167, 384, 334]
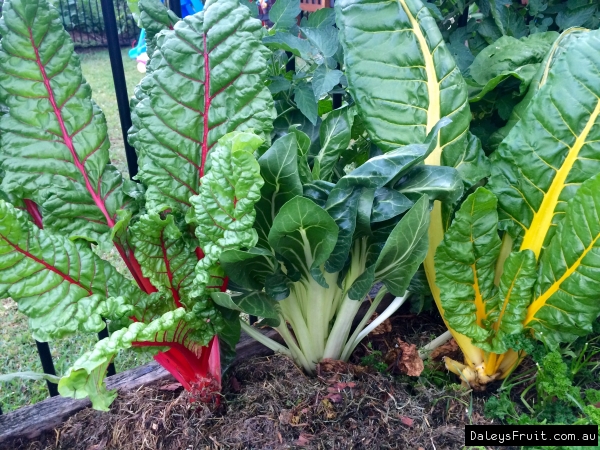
[491, 31, 600, 257]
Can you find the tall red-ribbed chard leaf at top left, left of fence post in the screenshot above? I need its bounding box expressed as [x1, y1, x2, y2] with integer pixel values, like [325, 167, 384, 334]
[0, 0, 131, 240]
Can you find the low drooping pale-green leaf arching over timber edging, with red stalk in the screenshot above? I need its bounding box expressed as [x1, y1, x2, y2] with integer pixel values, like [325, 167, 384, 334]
[58, 308, 212, 411]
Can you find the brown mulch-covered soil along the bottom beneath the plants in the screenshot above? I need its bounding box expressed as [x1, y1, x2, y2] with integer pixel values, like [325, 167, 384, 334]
[8, 312, 506, 450]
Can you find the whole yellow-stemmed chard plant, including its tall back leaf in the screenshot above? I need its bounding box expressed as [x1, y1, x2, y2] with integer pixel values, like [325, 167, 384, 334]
[336, 0, 600, 389]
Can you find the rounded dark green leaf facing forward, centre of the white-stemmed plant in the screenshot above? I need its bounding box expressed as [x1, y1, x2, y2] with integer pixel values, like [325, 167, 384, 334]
[269, 197, 338, 279]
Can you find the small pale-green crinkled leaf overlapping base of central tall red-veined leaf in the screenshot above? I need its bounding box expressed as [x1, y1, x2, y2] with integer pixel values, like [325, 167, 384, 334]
[190, 132, 264, 296]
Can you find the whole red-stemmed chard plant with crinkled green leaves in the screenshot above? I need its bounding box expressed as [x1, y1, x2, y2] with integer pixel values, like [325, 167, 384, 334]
[0, 0, 274, 410]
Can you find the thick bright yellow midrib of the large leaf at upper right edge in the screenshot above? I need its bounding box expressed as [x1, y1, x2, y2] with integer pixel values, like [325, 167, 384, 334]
[521, 99, 600, 259]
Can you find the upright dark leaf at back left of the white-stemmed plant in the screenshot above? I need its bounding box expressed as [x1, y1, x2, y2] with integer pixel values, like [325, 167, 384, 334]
[254, 132, 308, 249]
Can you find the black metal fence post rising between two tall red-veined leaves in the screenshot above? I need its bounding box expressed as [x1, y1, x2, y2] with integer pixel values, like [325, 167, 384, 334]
[101, 0, 138, 177]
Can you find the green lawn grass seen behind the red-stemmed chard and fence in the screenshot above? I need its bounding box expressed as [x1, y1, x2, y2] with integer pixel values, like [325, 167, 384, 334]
[0, 49, 149, 413]
